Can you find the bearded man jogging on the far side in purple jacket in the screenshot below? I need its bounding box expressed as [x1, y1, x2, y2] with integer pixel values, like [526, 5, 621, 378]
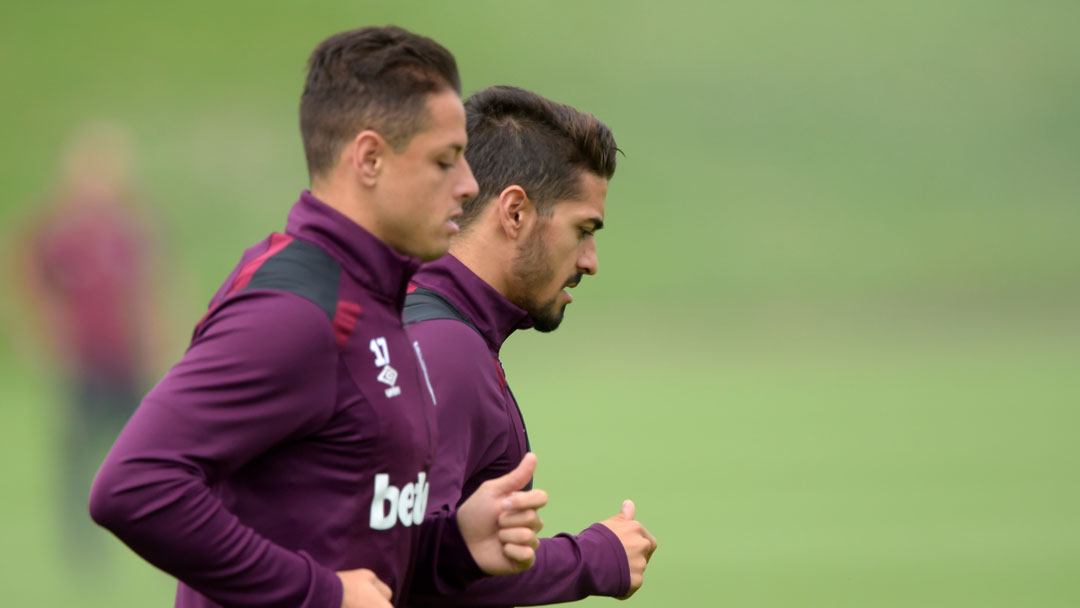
[404, 86, 657, 606]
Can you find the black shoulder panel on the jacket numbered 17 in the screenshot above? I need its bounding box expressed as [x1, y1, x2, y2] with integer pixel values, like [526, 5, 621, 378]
[244, 240, 341, 320]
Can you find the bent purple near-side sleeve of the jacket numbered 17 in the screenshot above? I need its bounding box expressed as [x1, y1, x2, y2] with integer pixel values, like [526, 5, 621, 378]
[90, 293, 341, 608]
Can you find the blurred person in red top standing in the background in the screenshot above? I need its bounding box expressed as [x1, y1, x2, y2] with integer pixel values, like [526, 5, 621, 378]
[23, 124, 152, 549]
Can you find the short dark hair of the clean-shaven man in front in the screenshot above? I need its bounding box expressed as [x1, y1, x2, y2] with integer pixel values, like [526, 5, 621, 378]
[300, 26, 461, 178]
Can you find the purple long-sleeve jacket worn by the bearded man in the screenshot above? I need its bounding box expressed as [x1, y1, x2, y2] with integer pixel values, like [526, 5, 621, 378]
[407, 255, 630, 606]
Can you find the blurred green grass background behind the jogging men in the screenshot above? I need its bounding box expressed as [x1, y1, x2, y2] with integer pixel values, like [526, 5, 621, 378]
[0, 0, 1080, 607]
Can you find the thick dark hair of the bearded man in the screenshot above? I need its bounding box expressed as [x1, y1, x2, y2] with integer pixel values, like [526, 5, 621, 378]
[458, 86, 620, 228]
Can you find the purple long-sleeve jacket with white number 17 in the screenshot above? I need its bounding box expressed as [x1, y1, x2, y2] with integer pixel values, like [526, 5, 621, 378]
[90, 191, 480, 608]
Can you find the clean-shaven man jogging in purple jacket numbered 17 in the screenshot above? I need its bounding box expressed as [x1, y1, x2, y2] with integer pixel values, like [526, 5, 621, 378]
[90, 27, 546, 608]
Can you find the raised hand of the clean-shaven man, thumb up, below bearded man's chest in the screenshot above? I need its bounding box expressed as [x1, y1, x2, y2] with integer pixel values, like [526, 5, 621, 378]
[458, 452, 548, 575]
